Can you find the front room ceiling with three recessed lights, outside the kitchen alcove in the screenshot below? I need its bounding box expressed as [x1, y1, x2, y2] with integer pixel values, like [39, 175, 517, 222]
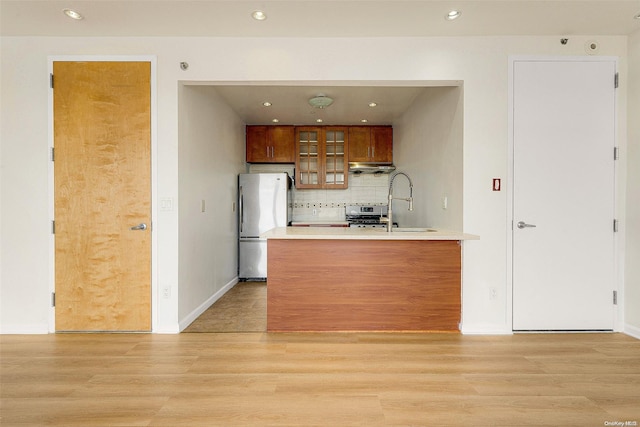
[0, 0, 640, 37]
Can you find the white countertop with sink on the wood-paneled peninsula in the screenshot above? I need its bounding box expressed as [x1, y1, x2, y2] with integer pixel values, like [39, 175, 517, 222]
[260, 227, 480, 240]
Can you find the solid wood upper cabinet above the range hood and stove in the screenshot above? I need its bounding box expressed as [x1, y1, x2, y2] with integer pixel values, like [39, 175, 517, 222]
[349, 126, 393, 164]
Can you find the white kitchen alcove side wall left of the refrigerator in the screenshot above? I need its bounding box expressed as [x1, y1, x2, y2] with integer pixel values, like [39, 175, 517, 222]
[178, 85, 245, 326]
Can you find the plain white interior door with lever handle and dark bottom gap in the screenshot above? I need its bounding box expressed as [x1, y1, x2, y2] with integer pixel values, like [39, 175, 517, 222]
[513, 58, 616, 330]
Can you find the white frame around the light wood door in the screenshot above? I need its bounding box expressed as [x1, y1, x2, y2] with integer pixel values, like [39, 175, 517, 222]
[47, 55, 158, 333]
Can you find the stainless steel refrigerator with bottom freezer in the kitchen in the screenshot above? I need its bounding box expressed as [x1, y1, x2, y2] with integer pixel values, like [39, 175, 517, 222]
[238, 173, 293, 280]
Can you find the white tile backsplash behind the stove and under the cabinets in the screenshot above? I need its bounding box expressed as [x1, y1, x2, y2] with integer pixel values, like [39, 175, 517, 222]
[248, 164, 389, 222]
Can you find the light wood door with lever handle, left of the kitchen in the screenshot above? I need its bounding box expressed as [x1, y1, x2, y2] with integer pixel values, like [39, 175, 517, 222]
[53, 62, 151, 331]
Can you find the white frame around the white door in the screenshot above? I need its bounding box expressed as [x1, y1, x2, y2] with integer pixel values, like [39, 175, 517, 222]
[506, 55, 624, 332]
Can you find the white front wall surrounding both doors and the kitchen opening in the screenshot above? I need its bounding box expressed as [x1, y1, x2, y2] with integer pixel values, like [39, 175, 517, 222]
[0, 36, 638, 332]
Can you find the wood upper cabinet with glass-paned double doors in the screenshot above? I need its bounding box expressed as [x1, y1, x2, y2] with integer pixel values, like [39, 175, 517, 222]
[296, 126, 349, 189]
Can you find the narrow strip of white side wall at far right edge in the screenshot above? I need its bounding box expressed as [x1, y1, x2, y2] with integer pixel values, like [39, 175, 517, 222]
[622, 31, 640, 338]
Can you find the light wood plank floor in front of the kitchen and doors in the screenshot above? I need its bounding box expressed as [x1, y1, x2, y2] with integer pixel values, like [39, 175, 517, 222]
[0, 333, 640, 427]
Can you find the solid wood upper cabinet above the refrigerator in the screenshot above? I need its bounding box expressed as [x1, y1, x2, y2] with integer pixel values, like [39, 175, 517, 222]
[247, 126, 295, 163]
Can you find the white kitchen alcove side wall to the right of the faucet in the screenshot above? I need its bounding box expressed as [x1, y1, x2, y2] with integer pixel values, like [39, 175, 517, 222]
[393, 87, 464, 231]
